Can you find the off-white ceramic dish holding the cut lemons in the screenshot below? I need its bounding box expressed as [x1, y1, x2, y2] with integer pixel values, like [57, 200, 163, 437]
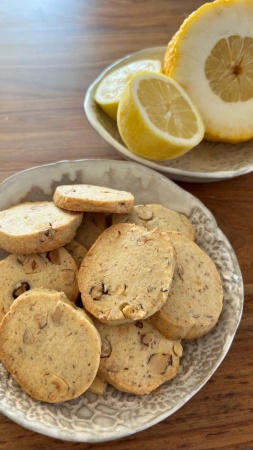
[84, 47, 253, 183]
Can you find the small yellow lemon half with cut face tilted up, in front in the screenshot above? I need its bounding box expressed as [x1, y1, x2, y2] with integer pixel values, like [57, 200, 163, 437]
[117, 71, 204, 161]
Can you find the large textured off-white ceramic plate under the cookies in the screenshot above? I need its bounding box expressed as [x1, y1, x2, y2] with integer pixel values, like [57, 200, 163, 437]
[0, 160, 243, 442]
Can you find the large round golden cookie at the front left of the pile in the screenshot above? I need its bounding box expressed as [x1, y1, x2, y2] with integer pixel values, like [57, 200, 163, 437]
[0, 289, 101, 403]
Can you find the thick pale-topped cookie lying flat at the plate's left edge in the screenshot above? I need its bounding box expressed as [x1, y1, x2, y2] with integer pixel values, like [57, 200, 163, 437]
[0, 202, 82, 254]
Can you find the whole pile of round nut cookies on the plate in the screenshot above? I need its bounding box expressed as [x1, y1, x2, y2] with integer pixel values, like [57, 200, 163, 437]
[0, 185, 223, 402]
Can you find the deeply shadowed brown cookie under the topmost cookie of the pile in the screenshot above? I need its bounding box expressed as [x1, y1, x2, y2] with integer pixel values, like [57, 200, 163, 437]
[75, 213, 107, 250]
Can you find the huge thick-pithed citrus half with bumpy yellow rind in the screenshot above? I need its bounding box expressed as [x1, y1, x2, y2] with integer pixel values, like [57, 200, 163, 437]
[163, 0, 253, 143]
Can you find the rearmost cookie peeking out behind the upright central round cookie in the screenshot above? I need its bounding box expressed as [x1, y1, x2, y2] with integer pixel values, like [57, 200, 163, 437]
[112, 204, 194, 240]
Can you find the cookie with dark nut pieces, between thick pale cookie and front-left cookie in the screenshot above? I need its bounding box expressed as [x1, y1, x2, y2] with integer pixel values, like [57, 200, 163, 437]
[0, 247, 79, 320]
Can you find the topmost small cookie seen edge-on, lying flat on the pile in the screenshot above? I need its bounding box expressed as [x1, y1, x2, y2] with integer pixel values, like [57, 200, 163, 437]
[53, 184, 134, 213]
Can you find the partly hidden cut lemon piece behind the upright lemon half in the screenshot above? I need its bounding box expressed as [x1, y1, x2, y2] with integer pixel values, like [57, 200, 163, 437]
[95, 59, 162, 120]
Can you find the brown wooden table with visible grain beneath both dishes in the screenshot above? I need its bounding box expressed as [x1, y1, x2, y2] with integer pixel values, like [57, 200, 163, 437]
[0, 0, 253, 450]
